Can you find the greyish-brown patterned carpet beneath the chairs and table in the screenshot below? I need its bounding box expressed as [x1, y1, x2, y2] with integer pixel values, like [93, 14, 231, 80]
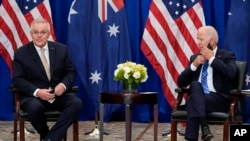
[0, 121, 223, 141]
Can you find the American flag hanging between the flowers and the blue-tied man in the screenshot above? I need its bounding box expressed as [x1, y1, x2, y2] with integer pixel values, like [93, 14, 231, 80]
[141, 0, 205, 107]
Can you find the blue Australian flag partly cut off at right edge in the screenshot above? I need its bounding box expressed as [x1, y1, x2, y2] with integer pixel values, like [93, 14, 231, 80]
[224, 0, 250, 123]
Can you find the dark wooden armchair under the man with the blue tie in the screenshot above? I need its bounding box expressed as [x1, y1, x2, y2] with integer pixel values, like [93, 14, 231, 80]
[171, 61, 247, 141]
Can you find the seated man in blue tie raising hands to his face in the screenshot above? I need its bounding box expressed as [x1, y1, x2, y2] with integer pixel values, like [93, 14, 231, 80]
[178, 26, 236, 141]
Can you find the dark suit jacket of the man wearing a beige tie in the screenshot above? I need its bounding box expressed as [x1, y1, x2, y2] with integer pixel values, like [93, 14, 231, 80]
[13, 41, 75, 103]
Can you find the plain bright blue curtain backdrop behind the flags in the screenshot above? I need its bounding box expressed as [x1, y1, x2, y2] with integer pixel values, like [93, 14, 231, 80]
[0, 0, 249, 122]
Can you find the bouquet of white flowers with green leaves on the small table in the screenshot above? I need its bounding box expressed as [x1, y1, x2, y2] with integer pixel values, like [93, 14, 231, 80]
[114, 61, 148, 84]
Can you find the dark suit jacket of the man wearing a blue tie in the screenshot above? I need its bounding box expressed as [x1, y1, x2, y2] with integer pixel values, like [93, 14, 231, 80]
[178, 48, 237, 98]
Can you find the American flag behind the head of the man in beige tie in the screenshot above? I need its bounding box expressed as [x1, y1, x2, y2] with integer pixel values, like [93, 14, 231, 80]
[0, 0, 56, 70]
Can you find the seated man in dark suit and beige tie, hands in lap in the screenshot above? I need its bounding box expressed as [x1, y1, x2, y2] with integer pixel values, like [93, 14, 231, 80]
[13, 19, 82, 141]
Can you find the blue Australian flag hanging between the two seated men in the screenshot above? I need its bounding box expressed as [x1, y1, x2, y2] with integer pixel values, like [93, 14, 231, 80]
[67, 0, 131, 120]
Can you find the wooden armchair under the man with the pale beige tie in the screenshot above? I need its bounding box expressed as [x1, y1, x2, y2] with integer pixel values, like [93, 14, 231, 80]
[9, 86, 79, 141]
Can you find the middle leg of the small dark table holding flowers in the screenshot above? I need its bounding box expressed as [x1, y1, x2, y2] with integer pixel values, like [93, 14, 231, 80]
[125, 104, 132, 141]
